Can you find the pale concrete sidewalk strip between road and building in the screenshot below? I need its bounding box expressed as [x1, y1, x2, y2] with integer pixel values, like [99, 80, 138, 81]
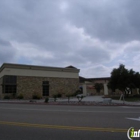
[0, 96, 140, 106]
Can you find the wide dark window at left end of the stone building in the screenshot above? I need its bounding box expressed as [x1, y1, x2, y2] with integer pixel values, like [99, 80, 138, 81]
[2, 75, 17, 93]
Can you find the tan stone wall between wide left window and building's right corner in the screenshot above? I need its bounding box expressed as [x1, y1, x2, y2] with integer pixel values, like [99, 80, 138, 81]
[17, 76, 79, 99]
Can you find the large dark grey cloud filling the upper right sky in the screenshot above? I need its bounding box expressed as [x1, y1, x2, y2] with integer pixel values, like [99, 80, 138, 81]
[67, 0, 140, 42]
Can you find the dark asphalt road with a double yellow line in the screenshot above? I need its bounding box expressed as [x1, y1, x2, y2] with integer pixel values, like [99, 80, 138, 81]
[0, 103, 140, 140]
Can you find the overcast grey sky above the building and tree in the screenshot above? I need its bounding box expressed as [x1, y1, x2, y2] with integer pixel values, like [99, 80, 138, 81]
[0, 0, 140, 78]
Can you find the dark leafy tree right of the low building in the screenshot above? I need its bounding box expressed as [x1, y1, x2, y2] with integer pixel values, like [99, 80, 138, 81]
[108, 64, 140, 94]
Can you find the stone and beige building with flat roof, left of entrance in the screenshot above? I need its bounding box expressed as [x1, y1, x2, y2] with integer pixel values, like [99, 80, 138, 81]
[0, 63, 80, 99]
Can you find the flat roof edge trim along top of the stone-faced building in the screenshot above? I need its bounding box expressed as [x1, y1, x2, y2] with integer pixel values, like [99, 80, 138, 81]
[0, 63, 80, 73]
